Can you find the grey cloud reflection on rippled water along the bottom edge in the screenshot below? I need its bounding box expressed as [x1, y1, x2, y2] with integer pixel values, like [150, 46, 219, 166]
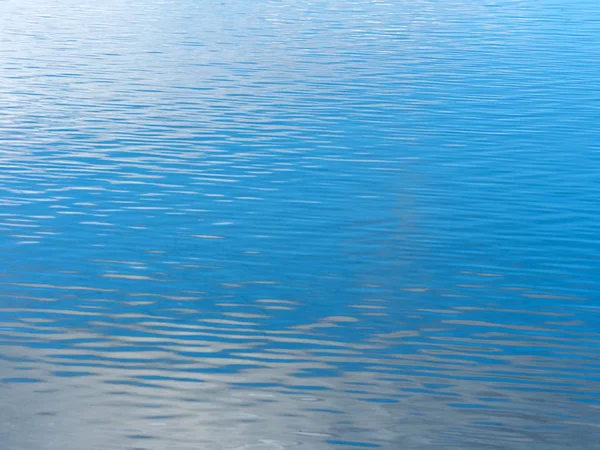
[3, 300, 588, 449]
